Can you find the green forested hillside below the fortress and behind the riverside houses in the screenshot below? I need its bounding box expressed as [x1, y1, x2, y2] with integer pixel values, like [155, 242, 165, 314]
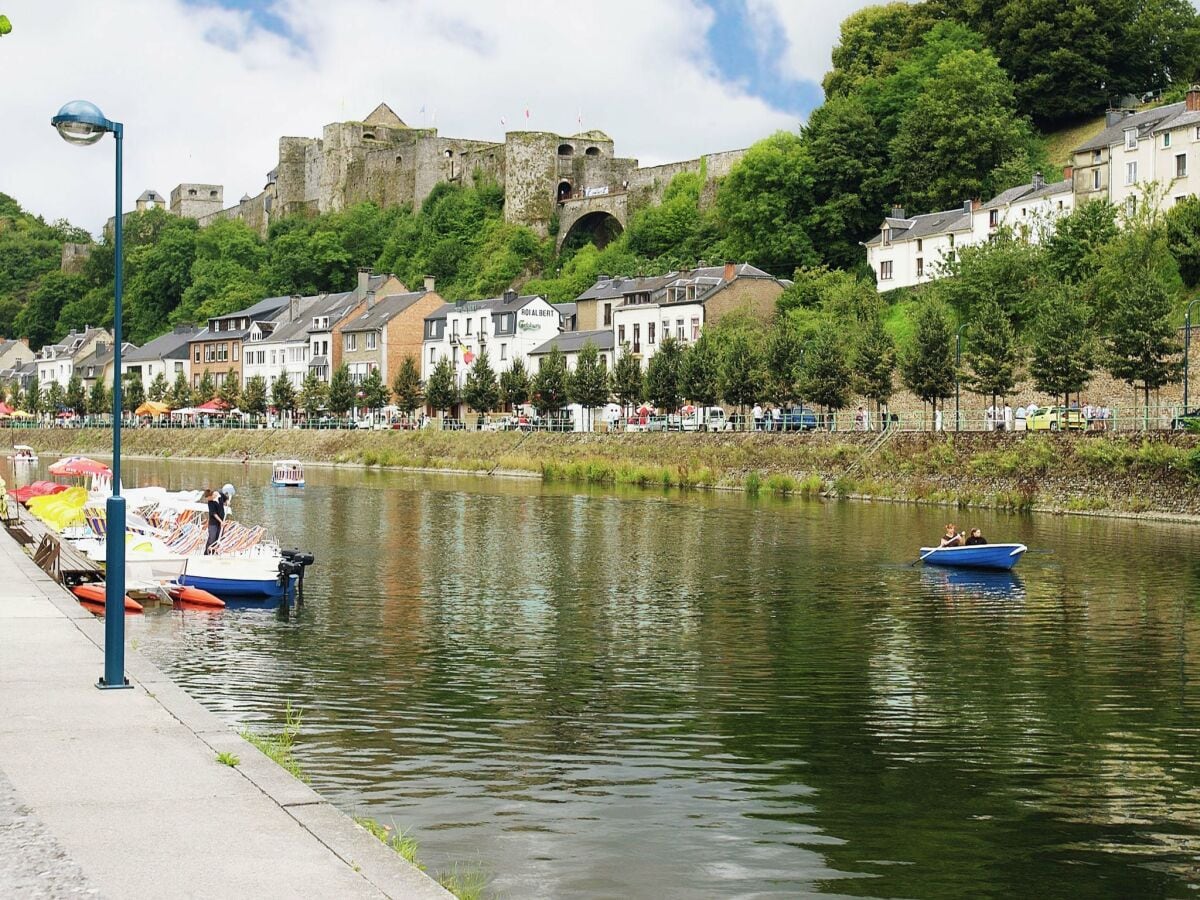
[7, 0, 1200, 347]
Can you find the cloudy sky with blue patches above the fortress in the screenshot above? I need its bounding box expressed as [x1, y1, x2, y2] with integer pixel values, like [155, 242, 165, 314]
[0, 0, 868, 233]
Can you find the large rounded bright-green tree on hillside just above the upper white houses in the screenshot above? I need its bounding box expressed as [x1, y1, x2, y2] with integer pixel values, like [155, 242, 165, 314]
[892, 50, 1033, 212]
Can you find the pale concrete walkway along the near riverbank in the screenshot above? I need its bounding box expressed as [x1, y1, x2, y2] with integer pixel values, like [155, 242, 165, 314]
[0, 530, 450, 900]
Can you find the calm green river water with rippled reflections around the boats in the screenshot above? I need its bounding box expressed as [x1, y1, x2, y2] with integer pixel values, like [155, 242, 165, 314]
[18, 463, 1200, 898]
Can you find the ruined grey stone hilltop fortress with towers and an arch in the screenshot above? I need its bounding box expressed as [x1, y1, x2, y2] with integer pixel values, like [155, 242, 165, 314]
[147, 103, 745, 246]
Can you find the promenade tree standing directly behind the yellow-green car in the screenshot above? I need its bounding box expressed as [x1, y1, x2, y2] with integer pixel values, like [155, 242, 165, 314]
[1030, 286, 1096, 406]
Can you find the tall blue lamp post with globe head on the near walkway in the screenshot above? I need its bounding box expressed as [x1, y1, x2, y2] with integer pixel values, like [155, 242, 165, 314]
[50, 100, 130, 690]
